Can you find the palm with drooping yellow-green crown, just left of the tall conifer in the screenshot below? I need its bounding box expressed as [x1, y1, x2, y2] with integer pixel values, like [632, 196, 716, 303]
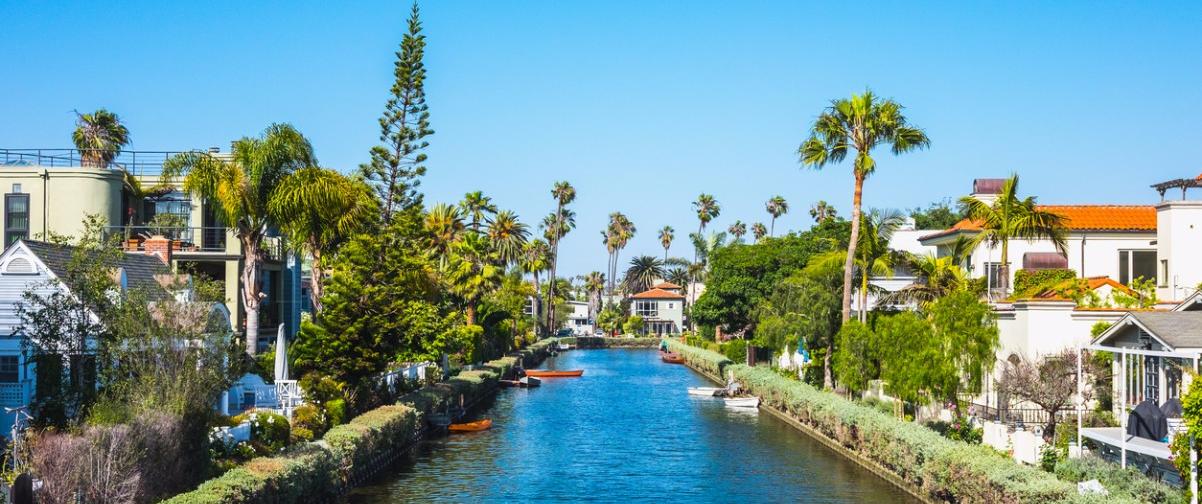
[268, 166, 380, 315]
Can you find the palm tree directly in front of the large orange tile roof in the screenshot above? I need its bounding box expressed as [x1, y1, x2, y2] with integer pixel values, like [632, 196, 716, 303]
[960, 174, 1067, 295]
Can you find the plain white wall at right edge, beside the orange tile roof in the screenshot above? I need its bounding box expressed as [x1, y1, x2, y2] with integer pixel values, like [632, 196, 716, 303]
[1156, 201, 1202, 300]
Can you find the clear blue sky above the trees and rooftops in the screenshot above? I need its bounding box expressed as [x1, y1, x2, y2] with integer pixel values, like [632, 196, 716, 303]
[0, 0, 1202, 274]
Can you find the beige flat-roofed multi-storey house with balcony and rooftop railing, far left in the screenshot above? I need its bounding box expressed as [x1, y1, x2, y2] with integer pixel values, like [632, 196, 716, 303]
[0, 148, 305, 345]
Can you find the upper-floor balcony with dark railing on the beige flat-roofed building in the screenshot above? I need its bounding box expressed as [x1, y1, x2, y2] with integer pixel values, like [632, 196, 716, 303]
[105, 226, 286, 261]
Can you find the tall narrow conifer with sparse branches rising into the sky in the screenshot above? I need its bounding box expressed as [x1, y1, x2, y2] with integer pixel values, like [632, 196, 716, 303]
[359, 2, 434, 226]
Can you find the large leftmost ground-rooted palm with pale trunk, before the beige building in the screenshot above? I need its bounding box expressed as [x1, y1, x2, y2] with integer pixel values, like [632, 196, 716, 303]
[163, 124, 317, 355]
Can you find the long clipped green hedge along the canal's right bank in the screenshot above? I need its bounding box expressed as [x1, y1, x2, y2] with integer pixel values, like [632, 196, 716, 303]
[668, 340, 1144, 503]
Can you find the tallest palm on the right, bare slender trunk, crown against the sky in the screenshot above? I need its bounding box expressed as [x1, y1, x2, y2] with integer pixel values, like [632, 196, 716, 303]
[798, 91, 930, 324]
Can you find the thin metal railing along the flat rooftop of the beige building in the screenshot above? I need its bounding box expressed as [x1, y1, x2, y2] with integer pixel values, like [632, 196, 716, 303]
[0, 149, 214, 176]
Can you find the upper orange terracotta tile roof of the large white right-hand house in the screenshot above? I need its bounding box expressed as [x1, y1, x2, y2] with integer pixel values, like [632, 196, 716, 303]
[918, 204, 1156, 241]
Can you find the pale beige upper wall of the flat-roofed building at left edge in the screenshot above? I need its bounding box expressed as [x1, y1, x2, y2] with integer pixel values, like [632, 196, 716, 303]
[0, 166, 123, 238]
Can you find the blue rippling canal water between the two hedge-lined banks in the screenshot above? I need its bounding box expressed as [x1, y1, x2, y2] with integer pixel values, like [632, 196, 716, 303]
[346, 350, 914, 504]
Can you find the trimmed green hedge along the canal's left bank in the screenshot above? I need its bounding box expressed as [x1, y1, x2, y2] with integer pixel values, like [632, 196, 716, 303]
[166, 338, 554, 504]
